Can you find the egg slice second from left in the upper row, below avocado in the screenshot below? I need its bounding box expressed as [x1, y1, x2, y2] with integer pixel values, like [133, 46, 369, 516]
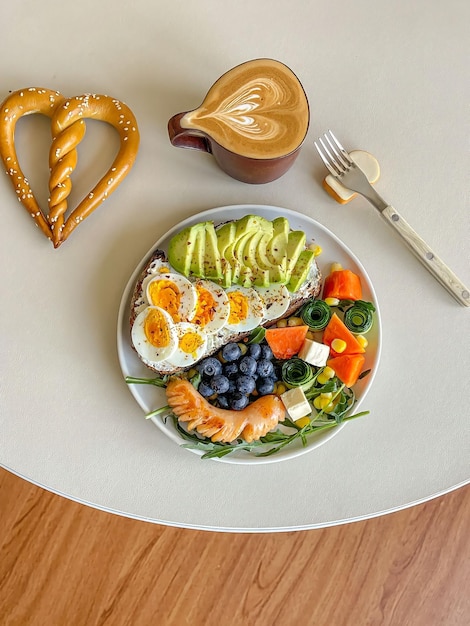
[190, 280, 230, 334]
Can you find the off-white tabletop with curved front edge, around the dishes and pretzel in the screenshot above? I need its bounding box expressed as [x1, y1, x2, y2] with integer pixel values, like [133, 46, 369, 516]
[0, 0, 470, 532]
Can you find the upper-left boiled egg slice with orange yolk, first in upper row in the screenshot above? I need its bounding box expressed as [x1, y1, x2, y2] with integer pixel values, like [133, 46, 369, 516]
[146, 272, 196, 324]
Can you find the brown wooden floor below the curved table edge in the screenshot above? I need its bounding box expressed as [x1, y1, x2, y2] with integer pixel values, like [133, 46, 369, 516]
[0, 470, 470, 626]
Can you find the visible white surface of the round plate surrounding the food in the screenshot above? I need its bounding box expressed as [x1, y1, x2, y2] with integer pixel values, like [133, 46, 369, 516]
[117, 204, 381, 464]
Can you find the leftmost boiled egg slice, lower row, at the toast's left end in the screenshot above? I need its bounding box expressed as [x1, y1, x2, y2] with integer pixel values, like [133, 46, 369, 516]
[131, 306, 178, 364]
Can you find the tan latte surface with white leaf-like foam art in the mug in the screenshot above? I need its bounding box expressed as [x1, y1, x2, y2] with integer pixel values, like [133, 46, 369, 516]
[181, 59, 309, 159]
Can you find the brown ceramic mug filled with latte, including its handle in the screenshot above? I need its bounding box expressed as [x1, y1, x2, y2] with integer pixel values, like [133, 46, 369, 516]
[168, 59, 310, 183]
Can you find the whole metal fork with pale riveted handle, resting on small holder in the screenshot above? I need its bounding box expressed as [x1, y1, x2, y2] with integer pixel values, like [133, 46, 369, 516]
[314, 130, 470, 306]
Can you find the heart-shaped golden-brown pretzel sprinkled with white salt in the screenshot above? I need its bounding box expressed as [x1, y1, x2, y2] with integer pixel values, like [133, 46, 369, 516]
[0, 87, 140, 248]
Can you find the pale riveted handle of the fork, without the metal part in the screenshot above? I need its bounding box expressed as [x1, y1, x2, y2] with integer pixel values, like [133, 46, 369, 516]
[381, 205, 470, 306]
